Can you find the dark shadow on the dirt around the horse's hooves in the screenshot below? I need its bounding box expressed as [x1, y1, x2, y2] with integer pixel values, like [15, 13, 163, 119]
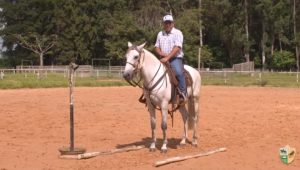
[116, 137, 181, 149]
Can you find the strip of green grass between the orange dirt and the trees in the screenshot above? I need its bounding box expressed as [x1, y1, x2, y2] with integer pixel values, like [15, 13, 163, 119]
[0, 72, 300, 89]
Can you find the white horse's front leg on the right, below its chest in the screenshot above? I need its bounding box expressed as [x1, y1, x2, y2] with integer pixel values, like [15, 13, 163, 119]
[161, 103, 168, 153]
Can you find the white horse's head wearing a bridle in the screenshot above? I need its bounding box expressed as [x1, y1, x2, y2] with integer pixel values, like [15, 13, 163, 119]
[123, 42, 146, 81]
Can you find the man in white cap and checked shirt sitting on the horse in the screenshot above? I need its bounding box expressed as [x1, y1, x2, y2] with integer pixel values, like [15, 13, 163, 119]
[155, 15, 187, 102]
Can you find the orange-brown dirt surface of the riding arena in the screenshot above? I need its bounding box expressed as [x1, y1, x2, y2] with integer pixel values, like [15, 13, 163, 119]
[0, 86, 300, 170]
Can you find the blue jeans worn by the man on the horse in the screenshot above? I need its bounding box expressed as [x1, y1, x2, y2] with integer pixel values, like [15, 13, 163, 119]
[169, 58, 187, 96]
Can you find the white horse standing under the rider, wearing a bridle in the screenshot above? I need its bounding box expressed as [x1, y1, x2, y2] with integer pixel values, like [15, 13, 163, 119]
[123, 42, 201, 152]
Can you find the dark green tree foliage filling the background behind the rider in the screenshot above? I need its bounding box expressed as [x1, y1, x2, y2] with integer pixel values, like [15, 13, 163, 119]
[0, 0, 300, 67]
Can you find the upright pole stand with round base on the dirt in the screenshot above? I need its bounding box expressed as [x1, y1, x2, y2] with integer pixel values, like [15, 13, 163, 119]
[58, 63, 86, 155]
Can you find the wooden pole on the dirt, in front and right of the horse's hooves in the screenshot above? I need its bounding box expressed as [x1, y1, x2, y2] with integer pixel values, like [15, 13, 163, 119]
[154, 148, 227, 167]
